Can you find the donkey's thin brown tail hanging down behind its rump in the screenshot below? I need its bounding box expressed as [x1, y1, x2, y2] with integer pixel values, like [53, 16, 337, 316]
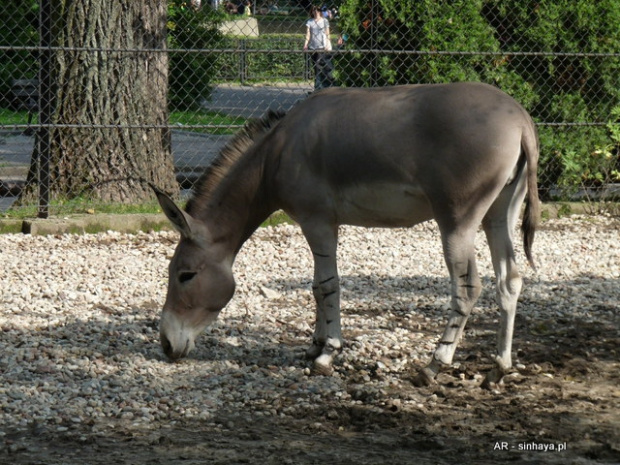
[521, 118, 540, 269]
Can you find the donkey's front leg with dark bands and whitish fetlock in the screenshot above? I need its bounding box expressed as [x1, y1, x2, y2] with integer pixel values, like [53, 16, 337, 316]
[302, 219, 342, 375]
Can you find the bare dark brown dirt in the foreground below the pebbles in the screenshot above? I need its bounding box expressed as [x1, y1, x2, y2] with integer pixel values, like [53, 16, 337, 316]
[0, 309, 620, 465]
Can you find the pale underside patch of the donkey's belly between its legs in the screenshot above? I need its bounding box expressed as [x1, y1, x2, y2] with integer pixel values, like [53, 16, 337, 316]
[336, 183, 433, 227]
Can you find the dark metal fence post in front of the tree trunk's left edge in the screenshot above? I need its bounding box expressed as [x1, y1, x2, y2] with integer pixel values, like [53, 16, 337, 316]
[37, 0, 53, 218]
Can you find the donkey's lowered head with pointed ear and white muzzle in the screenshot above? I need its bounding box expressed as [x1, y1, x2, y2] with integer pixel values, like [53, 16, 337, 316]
[155, 190, 235, 360]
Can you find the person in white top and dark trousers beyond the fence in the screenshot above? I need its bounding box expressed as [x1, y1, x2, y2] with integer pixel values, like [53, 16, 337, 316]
[304, 6, 334, 90]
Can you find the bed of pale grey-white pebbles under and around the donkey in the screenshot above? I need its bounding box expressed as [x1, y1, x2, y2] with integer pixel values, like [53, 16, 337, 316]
[0, 216, 620, 437]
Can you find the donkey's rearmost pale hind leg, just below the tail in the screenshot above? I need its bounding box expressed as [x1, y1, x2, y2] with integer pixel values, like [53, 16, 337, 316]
[482, 170, 527, 389]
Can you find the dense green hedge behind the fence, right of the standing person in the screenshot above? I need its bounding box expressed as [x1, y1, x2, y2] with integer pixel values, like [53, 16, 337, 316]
[337, 0, 620, 196]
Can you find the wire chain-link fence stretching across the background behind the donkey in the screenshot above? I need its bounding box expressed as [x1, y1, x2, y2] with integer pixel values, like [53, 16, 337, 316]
[0, 0, 620, 217]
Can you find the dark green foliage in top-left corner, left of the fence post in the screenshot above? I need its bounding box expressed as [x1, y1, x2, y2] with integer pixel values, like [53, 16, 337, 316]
[0, 0, 39, 108]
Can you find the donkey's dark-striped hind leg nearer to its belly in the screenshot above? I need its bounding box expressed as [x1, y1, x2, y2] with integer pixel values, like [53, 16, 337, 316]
[413, 226, 482, 386]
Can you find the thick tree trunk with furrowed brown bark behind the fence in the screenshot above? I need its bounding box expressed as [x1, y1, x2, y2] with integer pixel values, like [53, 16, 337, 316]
[23, 0, 178, 203]
